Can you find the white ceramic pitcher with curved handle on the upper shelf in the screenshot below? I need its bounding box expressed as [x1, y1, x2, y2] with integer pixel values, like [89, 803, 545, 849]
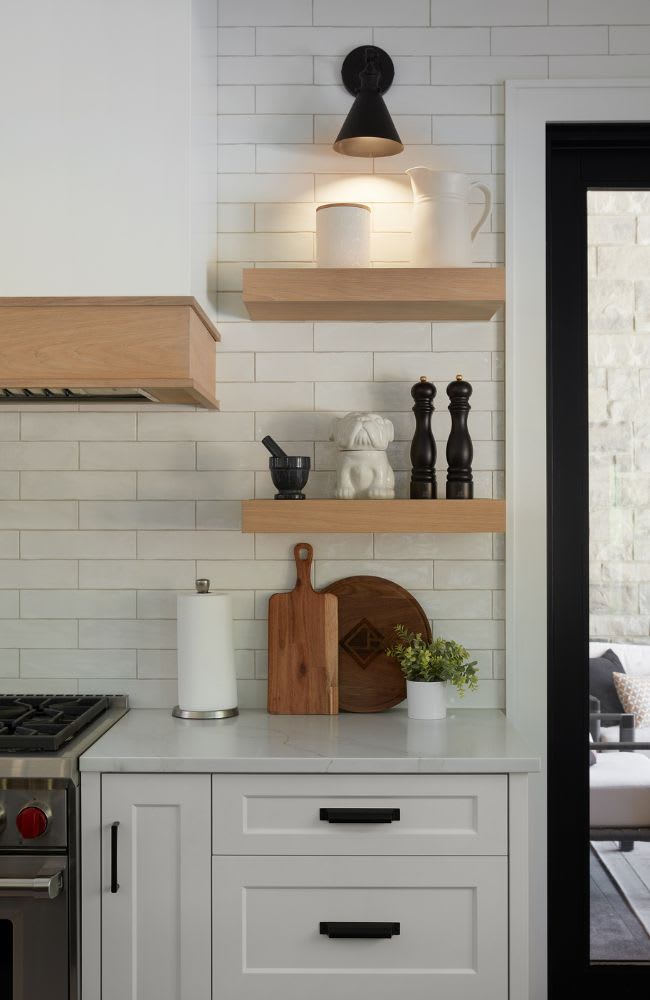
[406, 167, 492, 267]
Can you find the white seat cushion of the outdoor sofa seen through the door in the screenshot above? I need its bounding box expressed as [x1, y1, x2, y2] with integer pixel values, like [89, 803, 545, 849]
[589, 750, 650, 828]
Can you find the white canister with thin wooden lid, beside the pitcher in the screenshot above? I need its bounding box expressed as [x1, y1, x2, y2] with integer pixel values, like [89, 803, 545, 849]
[316, 202, 370, 267]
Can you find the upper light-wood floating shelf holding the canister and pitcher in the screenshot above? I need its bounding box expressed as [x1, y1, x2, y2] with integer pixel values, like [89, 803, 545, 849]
[244, 267, 505, 321]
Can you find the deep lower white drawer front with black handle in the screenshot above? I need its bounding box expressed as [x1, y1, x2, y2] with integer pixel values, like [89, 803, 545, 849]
[212, 857, 508, 1000]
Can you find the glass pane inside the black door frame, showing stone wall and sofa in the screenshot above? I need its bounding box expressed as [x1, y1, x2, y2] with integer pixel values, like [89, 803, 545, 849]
[587, 190, 650, 963]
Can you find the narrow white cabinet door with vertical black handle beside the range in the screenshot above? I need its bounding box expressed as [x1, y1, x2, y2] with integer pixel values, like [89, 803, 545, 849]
[102, 774, 211, 1000]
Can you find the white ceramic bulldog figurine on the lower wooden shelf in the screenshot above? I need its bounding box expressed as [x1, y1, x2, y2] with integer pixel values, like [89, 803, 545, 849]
[330, 413, 395, 500]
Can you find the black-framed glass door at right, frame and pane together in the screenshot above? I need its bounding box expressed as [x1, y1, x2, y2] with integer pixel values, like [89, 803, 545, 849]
[544, 122, 650, 996]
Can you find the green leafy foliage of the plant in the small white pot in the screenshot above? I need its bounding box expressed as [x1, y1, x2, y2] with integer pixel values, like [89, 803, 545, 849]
[386, 625, 478, 697]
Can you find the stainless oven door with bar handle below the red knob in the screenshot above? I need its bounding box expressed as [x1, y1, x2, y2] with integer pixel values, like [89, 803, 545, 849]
[0, 854, 70, 1000]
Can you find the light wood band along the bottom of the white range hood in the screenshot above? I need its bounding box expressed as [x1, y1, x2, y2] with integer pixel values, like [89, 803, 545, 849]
[0, 296, 221, 410]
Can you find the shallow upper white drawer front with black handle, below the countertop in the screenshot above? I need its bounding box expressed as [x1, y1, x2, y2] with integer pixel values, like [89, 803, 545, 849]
[212, 774, 508, 855]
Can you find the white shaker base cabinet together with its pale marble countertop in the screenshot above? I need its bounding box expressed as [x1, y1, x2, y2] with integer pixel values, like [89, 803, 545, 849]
[81, 710, 539, 1000]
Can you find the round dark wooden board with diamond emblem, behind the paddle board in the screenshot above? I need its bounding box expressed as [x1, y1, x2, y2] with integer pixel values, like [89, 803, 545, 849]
[323, 576, 431, 712]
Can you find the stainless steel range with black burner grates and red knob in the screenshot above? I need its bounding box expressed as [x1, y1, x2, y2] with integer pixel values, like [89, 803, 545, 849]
[0, 695, 128, 1000]
